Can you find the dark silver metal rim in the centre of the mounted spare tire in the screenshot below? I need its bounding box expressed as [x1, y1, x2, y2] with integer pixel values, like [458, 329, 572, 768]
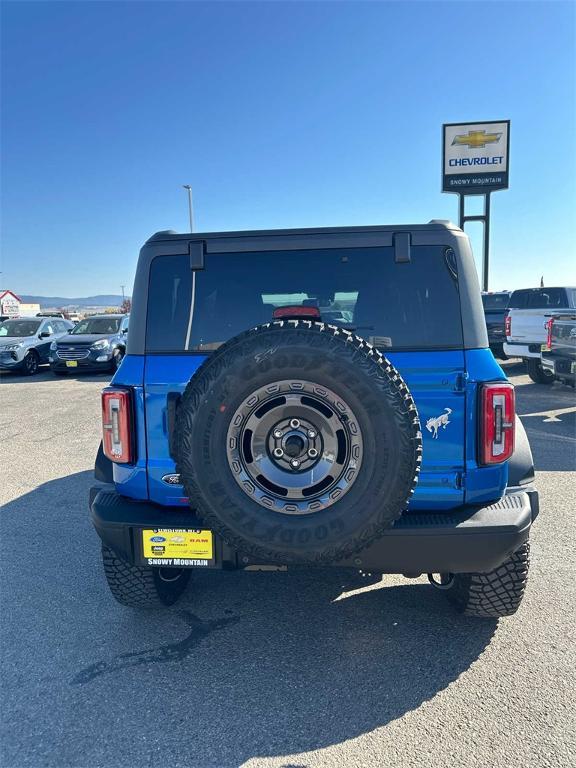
[226, 381, 362, 515]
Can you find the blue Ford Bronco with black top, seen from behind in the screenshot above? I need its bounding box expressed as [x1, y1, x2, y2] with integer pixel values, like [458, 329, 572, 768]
[90, 221, 538, 617]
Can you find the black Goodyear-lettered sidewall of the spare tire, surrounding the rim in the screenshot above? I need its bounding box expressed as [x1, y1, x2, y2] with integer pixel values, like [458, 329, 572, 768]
[177, 326, 416, 562]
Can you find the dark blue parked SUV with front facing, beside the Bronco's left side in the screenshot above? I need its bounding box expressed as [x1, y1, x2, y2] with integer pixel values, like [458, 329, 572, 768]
[50, 314, 129, 376]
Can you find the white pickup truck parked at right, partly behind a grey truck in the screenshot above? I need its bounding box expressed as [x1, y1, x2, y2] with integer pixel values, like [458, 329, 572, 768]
[504, 288, 576, 384]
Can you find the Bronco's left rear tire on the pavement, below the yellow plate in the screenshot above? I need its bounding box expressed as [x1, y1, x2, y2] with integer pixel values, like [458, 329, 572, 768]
[102, 546, 190, 608]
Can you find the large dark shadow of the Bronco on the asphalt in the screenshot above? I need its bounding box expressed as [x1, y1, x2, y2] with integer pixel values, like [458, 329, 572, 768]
[2, 472, 497, 768]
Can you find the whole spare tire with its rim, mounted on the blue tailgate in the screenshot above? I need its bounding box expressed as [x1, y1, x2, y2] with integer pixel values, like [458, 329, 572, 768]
[175, 320, 422, 563]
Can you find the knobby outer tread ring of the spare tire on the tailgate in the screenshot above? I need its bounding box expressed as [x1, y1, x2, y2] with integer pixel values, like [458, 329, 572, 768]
[176, 320, 422, 564]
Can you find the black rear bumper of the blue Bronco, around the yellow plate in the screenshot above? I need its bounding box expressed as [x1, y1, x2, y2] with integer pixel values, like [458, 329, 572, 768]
[90, 486, 538, 574]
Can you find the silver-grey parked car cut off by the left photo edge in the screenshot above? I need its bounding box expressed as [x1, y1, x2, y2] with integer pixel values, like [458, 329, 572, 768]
[0, 317, 73, 376]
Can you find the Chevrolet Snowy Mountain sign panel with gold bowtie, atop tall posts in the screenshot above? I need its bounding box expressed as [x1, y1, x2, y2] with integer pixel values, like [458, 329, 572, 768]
[442, 120, 510, 195]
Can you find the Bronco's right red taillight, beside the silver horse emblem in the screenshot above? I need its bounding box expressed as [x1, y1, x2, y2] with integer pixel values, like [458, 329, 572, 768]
[480, 383, 516, 464]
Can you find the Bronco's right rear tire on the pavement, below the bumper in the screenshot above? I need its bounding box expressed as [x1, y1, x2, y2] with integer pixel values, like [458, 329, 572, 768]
[446, 541, 530, 618]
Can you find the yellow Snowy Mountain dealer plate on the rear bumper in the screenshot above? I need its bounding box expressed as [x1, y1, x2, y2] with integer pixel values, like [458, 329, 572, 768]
[142, 528, 214, 568]
